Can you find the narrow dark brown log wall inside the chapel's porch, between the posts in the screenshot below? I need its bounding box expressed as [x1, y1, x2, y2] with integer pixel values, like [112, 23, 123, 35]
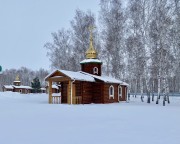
[61, 82, 68, 103]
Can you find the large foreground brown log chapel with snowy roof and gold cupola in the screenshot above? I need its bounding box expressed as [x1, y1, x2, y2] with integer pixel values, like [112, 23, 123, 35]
[45, 27, 128, 104]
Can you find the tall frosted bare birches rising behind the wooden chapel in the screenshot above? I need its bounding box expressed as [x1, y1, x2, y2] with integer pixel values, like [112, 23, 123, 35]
[44, 0, 180, 93]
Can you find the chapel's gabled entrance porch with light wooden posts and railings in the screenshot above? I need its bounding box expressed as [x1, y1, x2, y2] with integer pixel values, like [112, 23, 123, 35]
[45, 71, 82, 104]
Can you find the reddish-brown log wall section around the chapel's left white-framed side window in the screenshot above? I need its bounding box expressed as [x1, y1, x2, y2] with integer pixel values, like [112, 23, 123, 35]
[103, 84, 118, 103]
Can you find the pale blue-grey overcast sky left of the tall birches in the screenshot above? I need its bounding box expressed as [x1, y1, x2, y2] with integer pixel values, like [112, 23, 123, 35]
[0, 0, 99, 70]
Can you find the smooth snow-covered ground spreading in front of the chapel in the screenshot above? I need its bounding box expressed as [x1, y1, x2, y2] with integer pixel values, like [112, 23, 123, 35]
[0, 92, 180, 144]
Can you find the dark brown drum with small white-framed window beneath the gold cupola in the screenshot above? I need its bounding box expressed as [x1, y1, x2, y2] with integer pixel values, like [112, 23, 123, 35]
[81, 63, 101, 76]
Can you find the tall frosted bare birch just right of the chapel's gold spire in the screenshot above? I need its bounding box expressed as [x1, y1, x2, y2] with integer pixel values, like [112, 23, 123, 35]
[100, 0, 126, 79]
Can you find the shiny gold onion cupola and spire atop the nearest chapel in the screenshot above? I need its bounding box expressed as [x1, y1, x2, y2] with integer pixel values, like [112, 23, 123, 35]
[85, 26, 97, 59]
